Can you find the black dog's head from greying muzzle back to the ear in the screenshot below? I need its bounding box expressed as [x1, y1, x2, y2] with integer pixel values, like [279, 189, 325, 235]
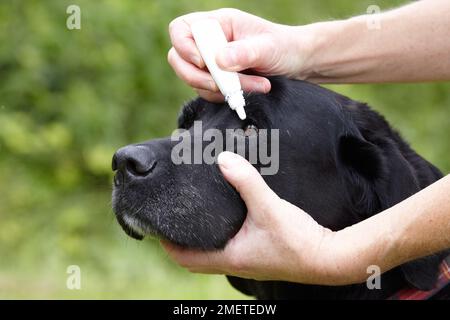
[113, 80, 352, 249]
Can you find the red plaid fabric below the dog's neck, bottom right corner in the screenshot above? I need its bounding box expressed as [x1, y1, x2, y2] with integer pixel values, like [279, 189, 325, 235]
[388, 257, 450, 300]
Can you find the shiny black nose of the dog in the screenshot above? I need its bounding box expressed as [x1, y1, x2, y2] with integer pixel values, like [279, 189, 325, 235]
[112, 145, 156, 185]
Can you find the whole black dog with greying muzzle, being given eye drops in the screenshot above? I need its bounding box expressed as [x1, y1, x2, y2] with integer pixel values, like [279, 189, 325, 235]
[113, 77, 448, 299]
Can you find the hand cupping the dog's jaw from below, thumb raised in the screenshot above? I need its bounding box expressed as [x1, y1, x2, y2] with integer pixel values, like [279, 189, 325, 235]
[161, 152, 342, 284]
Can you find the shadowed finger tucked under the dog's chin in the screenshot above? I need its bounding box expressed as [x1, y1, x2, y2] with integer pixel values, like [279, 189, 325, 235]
[161, 240, 225, 273]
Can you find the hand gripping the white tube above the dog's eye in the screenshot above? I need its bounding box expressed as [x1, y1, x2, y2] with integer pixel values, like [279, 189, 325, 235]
[168, 9, 314, 102]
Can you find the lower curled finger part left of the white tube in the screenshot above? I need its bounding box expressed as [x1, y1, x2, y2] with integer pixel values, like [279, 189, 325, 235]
[167, 47, 219, 91]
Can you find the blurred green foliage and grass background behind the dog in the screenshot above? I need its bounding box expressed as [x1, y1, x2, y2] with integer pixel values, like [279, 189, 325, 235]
[0, 0, 450, 299]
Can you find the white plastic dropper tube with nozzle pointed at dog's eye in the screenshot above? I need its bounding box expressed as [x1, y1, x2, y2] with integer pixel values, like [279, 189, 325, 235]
[191, 19, 246, 120]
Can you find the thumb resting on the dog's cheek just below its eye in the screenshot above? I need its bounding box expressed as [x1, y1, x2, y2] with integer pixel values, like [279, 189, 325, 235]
[217, 151, 280, 211]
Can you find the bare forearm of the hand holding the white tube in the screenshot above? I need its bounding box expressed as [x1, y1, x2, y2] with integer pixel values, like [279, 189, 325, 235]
[295, 0, 450, 83]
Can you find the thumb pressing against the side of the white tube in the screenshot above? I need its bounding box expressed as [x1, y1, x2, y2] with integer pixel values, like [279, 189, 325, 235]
[216, 35, 275, 71]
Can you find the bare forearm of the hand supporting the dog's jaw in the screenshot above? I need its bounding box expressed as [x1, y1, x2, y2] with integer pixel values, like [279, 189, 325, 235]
[330, 175, 450, 284]
